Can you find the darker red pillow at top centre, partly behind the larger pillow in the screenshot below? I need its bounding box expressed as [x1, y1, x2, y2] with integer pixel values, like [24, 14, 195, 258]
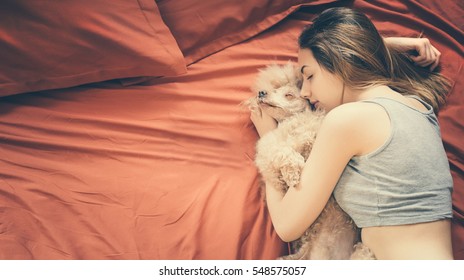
[156, 0, 336, 64]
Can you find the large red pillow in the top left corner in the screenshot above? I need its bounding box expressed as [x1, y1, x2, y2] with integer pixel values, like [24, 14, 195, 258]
[0, 0, 186, 96]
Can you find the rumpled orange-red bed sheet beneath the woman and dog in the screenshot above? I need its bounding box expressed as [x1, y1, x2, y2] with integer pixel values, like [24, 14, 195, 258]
[0, 0, 464, 259]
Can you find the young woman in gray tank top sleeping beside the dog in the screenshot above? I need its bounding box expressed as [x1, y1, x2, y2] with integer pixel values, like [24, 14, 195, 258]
[251, 8, 453, 259]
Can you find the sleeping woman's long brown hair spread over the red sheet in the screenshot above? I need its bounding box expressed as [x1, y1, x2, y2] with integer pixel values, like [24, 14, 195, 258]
[299, 8, 450, 112]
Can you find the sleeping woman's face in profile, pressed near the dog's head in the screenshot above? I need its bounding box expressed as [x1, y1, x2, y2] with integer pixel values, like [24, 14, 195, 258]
[298, 49, 344, 112]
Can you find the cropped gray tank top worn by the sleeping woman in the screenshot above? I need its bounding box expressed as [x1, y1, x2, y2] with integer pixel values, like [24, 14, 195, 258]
[334, 96, 453, 228]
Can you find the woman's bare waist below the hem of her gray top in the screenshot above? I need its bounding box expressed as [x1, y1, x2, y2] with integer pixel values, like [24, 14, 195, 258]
[361, 219, 453, 260]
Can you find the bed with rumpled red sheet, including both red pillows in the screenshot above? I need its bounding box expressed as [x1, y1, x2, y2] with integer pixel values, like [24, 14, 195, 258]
[0, 0, 464, 260]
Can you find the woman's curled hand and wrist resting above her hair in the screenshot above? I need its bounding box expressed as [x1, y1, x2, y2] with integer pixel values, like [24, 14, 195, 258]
[384, 37, 441, 71]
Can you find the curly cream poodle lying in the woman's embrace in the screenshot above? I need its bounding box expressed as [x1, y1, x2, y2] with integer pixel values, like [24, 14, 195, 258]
[244, 62, 374, 260]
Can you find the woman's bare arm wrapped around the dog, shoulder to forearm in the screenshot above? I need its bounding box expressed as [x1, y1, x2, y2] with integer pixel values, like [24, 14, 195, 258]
[260, 105, 366, 241]
